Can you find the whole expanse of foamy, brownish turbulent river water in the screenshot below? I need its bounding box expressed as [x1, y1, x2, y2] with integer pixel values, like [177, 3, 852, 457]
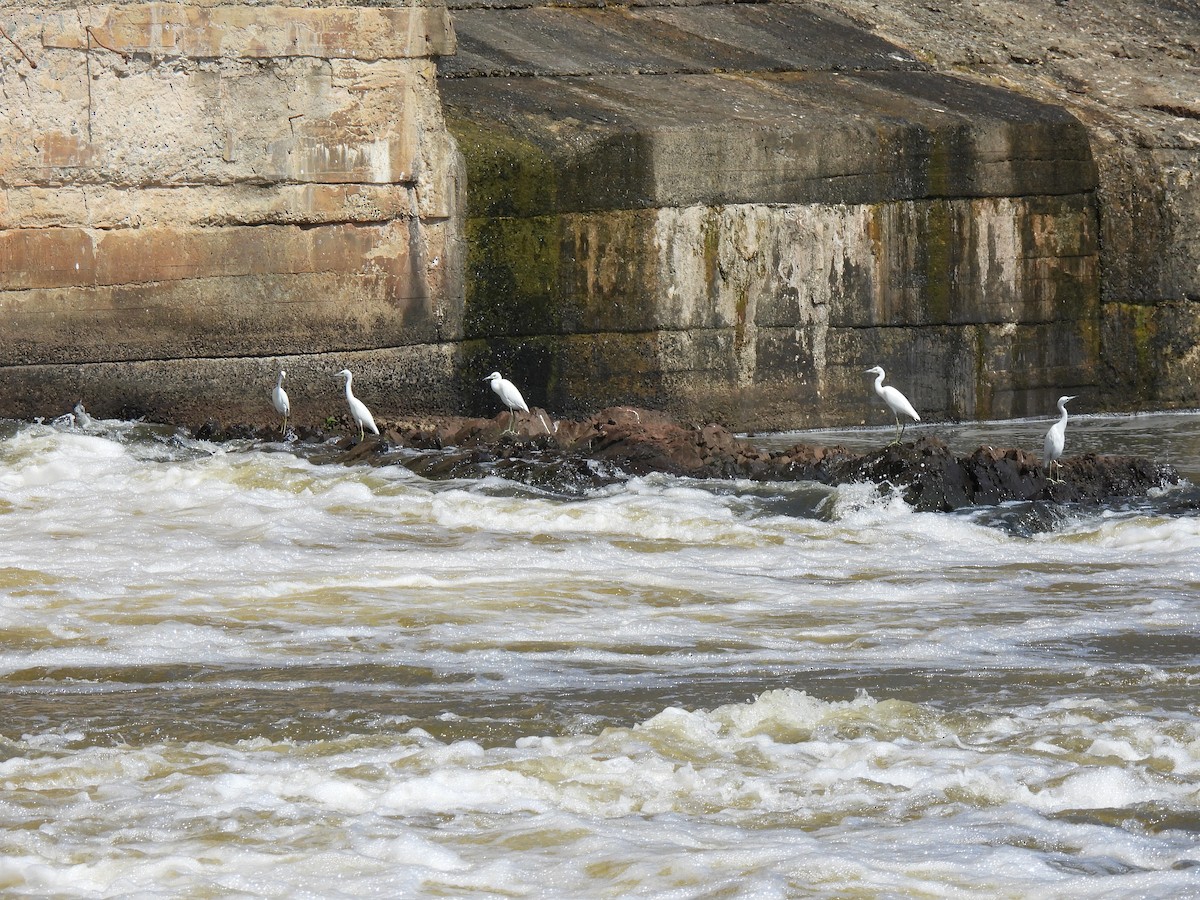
[0, 413, 1200, 899]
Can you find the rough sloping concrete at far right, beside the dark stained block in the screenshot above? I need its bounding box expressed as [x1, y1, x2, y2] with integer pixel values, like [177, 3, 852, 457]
[828, 0, 1200, 409]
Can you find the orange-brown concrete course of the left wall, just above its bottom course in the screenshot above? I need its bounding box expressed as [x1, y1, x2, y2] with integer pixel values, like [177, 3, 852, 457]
[0, 220, 455, 365]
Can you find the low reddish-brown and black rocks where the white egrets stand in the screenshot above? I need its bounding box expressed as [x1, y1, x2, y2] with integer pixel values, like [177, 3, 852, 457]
[196, 407, 1181, 511]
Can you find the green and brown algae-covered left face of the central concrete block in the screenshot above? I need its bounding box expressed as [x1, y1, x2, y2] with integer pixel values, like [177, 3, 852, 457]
[448, 112, 665, 414]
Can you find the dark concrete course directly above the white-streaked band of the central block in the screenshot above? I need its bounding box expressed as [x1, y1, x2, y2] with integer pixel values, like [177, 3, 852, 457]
[442, 72, 1096, 216]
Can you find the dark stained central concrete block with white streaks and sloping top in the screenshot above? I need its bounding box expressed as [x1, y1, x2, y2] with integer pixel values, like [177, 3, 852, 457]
[439, 4, 1100, 428]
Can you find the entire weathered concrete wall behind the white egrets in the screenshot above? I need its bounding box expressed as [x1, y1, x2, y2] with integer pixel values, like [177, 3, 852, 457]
[0, 0, 1200, 428]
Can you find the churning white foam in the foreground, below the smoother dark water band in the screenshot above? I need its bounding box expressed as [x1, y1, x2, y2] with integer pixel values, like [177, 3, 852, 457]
[0, 690, 1200, 896]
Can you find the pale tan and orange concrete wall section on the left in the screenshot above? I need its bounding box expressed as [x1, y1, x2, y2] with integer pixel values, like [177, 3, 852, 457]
[0, 0, 462, 421]
